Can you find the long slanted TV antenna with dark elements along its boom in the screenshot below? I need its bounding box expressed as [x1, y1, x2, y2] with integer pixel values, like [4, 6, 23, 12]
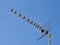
[10, 9, 49, 40]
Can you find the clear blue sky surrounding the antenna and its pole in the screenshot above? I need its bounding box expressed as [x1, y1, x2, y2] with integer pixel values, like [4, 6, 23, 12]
[0, 0, 60, 45]
